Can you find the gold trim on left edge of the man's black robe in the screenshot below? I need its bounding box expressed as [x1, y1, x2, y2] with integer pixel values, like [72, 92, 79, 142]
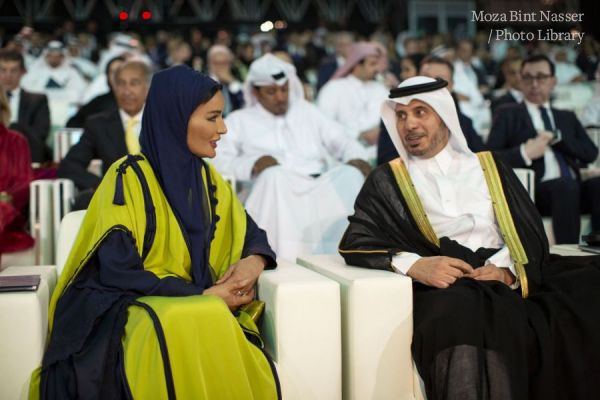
[389, 158, 440, 247]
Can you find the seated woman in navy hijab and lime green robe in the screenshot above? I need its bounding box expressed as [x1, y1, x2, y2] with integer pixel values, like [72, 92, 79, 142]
[31, 66, 280, 399]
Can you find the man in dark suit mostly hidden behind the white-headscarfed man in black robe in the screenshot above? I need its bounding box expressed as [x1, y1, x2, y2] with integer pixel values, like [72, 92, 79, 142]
[377, 56, 486, 165]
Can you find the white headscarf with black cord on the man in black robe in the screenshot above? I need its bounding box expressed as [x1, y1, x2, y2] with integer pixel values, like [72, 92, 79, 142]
[381, 76, 473, 160]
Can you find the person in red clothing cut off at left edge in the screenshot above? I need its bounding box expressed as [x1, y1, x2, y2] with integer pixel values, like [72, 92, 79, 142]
[0, 90, 33, 257]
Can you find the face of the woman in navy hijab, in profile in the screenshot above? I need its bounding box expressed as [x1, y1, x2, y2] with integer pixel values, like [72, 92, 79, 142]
[187, 91, 227, 158]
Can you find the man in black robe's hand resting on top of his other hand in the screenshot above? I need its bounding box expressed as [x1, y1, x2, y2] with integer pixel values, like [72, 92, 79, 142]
[406, 256, 473, 289]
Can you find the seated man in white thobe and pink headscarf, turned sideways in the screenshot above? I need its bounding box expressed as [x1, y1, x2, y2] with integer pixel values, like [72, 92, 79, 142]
[317, 42, 388, 156]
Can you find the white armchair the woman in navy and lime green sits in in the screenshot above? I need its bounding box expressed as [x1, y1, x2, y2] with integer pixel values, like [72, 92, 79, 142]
[0, 211, 342, 400]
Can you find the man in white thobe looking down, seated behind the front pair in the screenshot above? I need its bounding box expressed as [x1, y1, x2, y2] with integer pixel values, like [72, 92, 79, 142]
[214, 54, 369, 260]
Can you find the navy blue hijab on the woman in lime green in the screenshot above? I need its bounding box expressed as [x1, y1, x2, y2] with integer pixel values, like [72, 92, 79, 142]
[140, 66, 220, 289]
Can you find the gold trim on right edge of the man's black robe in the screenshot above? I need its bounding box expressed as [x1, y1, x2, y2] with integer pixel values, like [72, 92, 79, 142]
[477, 151, 529, 298]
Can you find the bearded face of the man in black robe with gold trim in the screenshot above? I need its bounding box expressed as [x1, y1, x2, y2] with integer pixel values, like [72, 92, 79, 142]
[396, 100, 449, 159]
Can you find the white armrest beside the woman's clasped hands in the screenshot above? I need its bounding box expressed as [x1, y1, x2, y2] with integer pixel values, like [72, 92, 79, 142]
[258, 261, 342, 400]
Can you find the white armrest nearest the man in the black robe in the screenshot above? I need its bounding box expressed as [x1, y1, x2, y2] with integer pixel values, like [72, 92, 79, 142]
[298, 255, 425, 400]
